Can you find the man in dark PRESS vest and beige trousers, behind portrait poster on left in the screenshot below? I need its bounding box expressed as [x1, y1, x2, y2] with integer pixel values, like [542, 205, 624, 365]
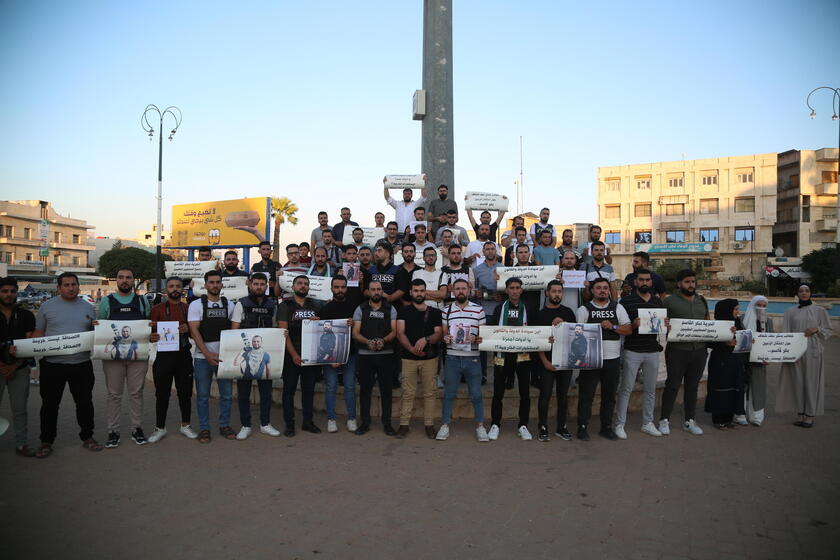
[97, 268, 151, 448]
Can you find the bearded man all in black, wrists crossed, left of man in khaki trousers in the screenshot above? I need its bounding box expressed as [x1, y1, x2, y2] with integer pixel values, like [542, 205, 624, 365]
[353, 282, 397, 436]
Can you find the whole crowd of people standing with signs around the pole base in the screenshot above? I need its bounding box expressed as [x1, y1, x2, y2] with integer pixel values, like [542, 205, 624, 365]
[0, 185, 831, 458]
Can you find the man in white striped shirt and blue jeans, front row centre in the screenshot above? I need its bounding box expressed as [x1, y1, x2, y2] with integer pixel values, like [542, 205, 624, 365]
[435, 278, 490, 441]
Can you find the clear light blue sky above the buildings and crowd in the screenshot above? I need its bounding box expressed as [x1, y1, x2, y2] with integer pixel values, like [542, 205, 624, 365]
[0, 0, 840, 247]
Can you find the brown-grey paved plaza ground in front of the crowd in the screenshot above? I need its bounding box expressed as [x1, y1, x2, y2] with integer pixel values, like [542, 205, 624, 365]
[0, 338, 840, 560]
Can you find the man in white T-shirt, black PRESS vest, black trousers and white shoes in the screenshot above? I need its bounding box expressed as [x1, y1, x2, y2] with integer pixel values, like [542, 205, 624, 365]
[577, 278, 633, 441]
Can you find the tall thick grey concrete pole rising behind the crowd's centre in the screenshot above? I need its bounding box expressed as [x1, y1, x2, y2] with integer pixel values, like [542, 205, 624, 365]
[421, 0, 455, 199]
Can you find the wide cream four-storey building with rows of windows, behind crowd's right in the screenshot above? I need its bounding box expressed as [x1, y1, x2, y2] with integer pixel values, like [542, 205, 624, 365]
[598, 153, 777, 282]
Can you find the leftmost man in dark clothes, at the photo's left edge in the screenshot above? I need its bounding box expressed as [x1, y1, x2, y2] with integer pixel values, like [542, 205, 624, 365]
[0, 276, 35, 457]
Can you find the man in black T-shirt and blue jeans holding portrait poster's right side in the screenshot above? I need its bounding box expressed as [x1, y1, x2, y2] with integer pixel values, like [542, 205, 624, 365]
[318, 276, 361, 433]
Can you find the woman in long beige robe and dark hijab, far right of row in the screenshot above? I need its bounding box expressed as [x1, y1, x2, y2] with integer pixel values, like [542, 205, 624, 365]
[776, 284, 831, 428]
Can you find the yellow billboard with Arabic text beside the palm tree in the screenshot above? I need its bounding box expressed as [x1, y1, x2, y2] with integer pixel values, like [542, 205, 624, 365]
[172, 197, 271, 248]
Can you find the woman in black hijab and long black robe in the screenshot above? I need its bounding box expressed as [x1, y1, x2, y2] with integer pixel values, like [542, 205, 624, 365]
[706, 298, 747, 430]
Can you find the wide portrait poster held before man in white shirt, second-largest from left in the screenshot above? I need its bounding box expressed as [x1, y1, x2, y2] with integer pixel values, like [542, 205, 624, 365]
[218, 328, 286, 379]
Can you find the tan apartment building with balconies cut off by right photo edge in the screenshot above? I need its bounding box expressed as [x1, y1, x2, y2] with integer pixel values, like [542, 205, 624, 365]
[773, 148, 837, 257]
